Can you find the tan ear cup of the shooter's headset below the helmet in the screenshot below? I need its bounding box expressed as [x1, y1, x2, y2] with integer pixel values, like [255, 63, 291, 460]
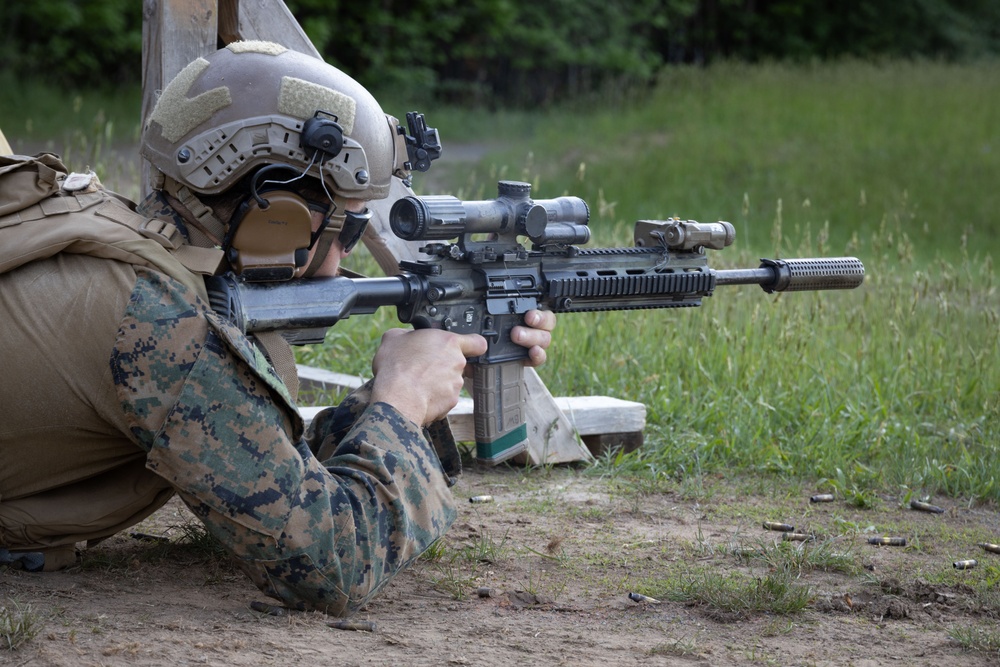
[224, 190, 312, 282]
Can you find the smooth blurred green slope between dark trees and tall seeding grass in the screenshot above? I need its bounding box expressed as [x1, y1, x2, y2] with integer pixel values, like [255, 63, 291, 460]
[446, 62, 1000, 261]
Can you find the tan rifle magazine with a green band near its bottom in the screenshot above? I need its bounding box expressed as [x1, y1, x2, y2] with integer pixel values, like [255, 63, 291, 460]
[472, 359, 528, 463]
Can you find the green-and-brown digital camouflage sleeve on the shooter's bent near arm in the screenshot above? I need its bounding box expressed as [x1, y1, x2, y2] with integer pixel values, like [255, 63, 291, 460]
[111, 270, 455, 615]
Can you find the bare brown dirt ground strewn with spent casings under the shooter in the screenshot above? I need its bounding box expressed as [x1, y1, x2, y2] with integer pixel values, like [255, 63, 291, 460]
[0, 468, 1000, 667]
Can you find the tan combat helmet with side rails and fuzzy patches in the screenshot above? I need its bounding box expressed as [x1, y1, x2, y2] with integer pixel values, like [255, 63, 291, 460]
[140, 41, 409, 200]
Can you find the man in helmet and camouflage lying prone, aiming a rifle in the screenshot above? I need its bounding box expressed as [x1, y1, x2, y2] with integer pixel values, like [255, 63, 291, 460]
[0, 42, 555, 615]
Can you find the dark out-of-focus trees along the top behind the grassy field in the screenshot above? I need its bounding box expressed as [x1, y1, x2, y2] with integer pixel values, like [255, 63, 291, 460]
[0, 0, 1000, 106]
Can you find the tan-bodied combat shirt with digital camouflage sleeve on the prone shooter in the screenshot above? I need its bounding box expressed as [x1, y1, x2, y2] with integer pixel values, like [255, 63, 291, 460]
[0, 162, 455, 614]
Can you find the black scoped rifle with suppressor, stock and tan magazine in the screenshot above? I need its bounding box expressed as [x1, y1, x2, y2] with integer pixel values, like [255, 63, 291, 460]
[207, 181, 864, 463]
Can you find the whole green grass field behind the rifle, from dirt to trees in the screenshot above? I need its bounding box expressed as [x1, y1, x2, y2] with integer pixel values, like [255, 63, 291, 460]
[0, 62, 1000, 500]
